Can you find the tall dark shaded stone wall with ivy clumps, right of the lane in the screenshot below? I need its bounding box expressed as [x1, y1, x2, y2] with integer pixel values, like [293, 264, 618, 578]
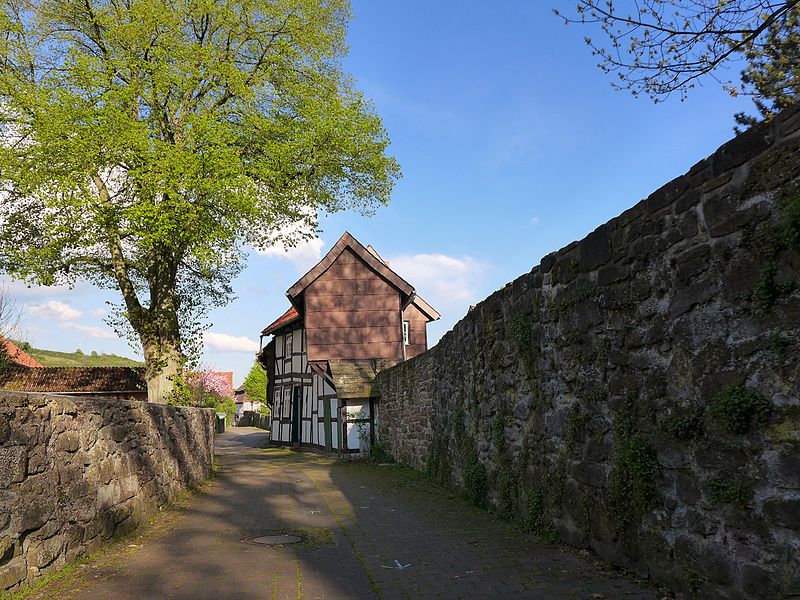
[378, 111, 800, 598]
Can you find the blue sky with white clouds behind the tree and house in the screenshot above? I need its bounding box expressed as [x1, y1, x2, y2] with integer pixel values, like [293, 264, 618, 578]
[6, 0, 750, 385]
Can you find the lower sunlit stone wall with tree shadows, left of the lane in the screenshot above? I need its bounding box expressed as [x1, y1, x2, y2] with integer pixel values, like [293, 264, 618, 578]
[0, 392, 214, 594]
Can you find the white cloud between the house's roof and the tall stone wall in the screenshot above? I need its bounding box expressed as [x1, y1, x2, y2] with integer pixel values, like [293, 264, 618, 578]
[389, 254, 486, 308]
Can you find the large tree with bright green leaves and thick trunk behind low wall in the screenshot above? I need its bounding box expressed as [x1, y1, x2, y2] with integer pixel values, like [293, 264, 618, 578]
[0, 0, 399, 401]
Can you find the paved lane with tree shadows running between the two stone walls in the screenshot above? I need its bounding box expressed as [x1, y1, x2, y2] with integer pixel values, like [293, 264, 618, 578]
[29, 428, 659, 600]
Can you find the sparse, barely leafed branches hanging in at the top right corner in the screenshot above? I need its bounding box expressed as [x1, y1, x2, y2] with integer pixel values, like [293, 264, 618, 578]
[556, 0, 800, 124]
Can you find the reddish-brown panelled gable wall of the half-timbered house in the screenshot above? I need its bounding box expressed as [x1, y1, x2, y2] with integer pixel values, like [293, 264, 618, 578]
[304, 248, 403, 360]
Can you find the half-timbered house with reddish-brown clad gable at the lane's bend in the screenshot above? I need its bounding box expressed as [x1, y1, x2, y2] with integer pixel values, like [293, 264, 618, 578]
[258, 233, 439, 453]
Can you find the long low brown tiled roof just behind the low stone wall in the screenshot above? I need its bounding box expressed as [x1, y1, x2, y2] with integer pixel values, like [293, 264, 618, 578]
[0, 367, 147, 393]
